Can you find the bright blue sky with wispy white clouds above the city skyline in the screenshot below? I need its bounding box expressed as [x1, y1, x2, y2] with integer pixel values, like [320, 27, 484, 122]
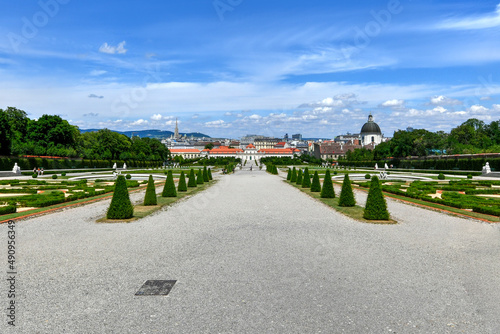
[0, 0, 500, 138]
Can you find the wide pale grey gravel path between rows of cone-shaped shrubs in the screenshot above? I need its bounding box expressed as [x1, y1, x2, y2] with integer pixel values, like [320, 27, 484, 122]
[0, 168, 500, 334]
